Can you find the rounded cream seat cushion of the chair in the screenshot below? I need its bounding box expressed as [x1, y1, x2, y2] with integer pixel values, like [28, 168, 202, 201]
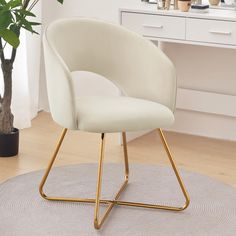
[76, 97, 174, 133]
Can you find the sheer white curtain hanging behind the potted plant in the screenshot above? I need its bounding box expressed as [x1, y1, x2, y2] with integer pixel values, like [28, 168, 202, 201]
[0, 3, 41, 129]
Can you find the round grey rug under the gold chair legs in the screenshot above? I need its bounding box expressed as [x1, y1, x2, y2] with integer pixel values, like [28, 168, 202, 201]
[0, 164, 236, 236]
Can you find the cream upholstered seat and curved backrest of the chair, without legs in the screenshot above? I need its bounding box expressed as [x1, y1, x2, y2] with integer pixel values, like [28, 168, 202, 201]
[43, 18, 176, 133]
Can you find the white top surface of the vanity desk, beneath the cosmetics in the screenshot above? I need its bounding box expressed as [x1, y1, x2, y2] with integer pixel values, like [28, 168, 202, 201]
[120, 2, 236, 21]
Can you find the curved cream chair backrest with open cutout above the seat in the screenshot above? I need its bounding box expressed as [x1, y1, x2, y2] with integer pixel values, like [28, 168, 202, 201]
[44, 18, 176, 129]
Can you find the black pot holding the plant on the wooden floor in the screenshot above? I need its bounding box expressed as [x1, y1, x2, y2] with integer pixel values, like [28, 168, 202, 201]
[0, 128, 19, 157]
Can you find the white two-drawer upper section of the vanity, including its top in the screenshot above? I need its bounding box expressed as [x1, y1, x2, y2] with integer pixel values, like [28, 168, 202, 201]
[120, 9, 236, 48]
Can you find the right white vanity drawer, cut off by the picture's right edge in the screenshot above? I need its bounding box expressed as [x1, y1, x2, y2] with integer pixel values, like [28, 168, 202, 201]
[186, 19, 236, 45]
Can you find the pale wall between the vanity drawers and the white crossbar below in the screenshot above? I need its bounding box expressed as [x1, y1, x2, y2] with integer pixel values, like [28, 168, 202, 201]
[162, 43, 236, 96]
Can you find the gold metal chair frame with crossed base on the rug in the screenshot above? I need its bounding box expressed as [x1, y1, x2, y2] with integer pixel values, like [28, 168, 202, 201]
[39, 129, 190, 229]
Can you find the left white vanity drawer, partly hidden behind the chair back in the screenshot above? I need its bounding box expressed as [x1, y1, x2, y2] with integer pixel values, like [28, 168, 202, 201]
[121, 12, 185, 40]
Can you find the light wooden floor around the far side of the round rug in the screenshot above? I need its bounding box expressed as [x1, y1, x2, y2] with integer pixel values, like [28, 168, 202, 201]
[0, 113, 236, 187]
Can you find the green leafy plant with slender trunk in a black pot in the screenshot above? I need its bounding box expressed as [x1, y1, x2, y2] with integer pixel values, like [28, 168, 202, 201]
[0, 0, 64, 157]
